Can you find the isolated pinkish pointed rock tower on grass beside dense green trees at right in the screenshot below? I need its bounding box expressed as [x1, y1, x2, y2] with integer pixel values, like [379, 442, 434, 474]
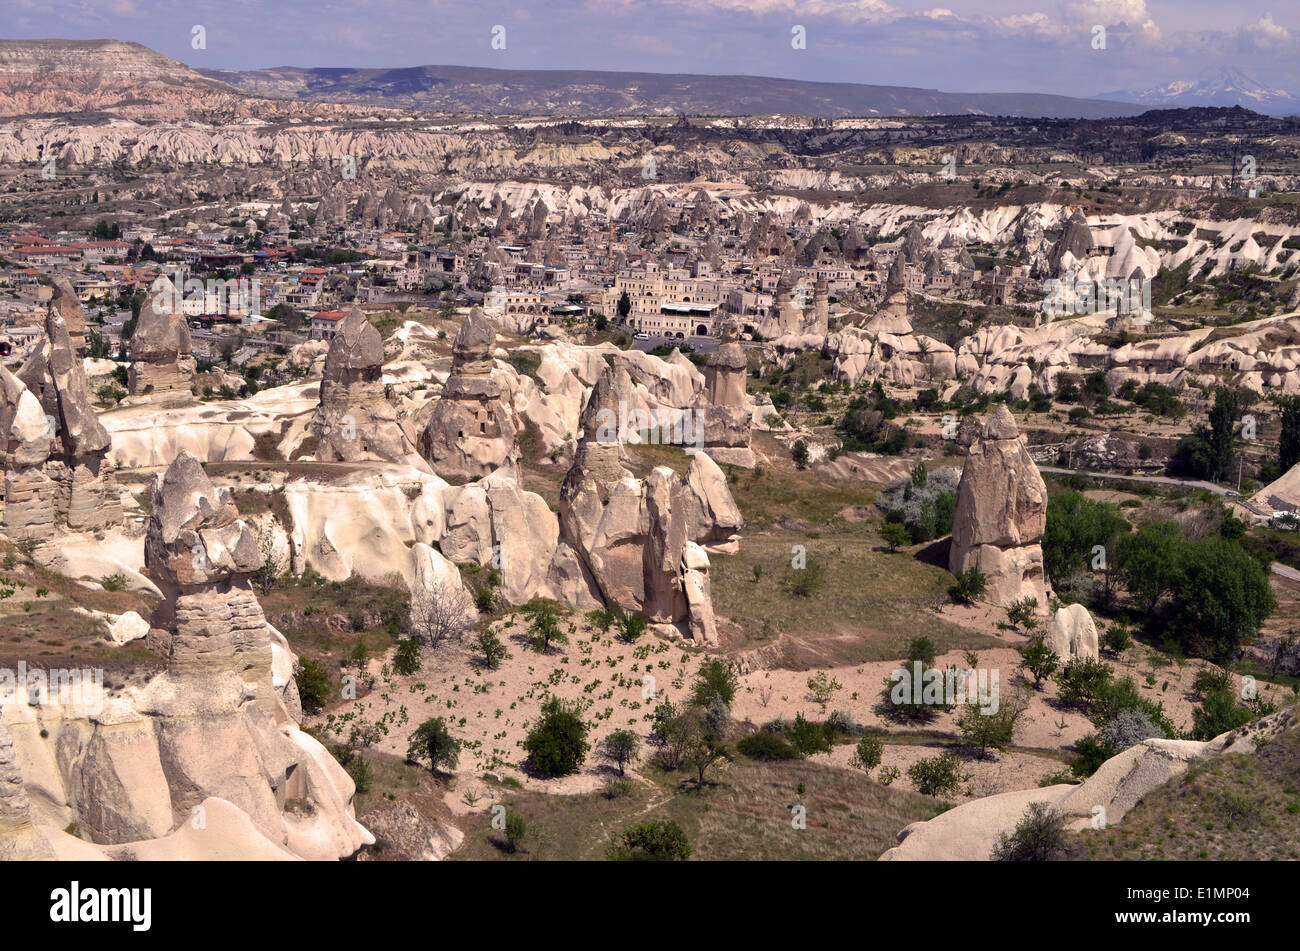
[949, 405, 1048, 607]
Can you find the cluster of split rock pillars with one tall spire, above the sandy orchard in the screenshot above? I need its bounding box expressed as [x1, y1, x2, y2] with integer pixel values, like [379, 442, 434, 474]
[560, 366, 742, 644]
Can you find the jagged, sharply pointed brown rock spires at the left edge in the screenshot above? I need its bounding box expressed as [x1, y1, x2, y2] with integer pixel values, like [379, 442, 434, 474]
[5, 297, 122, 531]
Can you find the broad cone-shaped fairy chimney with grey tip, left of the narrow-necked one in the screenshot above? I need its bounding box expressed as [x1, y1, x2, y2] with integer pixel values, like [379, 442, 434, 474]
[311, 308, 424, 468]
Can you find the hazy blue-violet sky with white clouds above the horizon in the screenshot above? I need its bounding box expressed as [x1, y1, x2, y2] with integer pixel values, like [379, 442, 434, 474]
[0, 0, 1300, 96]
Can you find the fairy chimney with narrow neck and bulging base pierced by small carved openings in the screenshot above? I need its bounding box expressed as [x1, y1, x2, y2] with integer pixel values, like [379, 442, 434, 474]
[420, 307, 517, 483]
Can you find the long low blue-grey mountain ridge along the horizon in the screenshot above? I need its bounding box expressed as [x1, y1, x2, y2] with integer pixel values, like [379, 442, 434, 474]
[199, 66, 1141, 118]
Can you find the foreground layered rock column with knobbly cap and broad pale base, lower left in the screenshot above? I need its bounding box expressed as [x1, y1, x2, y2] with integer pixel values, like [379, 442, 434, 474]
[0, 452, 373, 860]
